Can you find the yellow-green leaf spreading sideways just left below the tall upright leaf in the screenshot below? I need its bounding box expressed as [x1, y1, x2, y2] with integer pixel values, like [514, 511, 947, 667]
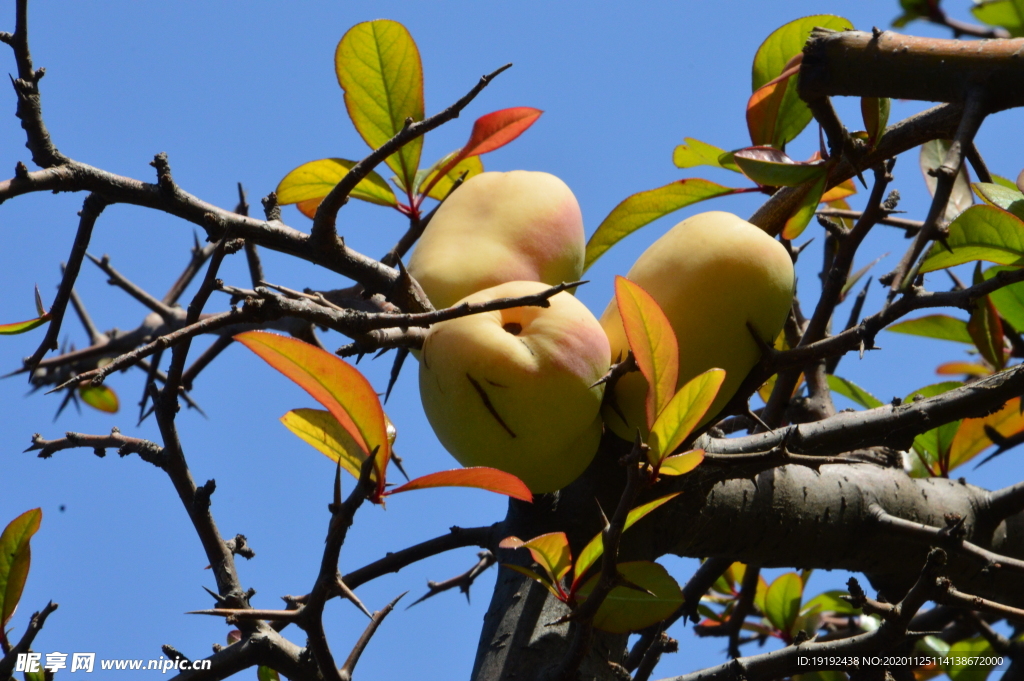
[276, 159, 398, 217]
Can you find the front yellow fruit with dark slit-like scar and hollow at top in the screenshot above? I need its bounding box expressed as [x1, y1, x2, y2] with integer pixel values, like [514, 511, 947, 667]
[420, 282, 609, 493]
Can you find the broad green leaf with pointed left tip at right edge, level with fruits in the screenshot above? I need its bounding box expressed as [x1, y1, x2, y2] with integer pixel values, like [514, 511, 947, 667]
[921, 204, 1024, 273]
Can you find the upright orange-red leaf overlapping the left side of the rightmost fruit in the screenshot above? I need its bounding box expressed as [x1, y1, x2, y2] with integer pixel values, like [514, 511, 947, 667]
[615, 276, 679, 428]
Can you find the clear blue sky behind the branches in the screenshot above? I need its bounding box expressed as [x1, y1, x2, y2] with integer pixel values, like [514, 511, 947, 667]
[0, 0, 1024, 679]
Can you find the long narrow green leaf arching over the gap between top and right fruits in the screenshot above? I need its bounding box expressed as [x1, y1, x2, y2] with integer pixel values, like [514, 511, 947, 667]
[584, 178, 738, 270]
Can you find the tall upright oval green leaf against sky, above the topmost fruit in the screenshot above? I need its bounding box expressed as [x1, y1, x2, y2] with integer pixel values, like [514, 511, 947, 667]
[334, 19, 424, 186]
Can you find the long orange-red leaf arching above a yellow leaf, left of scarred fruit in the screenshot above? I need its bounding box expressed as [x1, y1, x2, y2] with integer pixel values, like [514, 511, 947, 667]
[234, 331, 391, 500]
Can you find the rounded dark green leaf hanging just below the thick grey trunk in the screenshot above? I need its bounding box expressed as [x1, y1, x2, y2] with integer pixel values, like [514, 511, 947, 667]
[577, 560, 683, 634]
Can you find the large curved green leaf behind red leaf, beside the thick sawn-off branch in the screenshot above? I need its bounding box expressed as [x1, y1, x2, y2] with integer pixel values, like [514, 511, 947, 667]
[749, 14, 853, 148]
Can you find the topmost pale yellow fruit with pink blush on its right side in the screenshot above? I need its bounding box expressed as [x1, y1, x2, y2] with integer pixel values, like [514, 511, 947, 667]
[409, 170, 586, 308]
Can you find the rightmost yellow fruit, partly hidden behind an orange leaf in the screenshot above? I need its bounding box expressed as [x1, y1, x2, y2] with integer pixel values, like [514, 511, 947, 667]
[601, 211, 795, 439]
